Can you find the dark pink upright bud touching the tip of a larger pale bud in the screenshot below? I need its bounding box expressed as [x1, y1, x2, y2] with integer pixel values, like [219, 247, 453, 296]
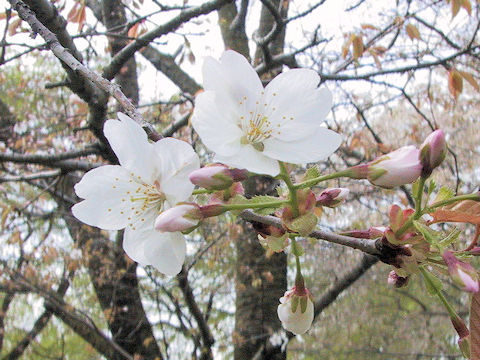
[420, 130, 447, 178]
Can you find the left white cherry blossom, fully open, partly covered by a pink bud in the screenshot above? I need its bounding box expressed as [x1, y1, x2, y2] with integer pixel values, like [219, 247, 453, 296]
[72, 113, 200, 275]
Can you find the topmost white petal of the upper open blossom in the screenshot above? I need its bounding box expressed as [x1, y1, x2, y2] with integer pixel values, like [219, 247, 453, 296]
[203, 50, 263, 108]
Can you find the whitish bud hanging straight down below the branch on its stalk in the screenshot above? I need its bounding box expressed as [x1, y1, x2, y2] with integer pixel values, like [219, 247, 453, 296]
[277, 287, 314, 335]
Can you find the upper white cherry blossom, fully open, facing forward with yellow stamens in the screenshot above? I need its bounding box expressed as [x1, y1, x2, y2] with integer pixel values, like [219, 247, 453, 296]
[192, 50, 341, 176]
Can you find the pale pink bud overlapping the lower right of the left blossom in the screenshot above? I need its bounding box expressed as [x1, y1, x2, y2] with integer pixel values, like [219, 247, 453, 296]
[155, 203, 203, 232]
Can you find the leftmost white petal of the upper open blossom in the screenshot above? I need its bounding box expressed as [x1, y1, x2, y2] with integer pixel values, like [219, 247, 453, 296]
[191, 91, 243, 156]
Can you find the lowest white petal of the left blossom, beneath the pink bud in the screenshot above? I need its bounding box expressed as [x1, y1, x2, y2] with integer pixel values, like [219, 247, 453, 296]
[145, 232, 187, 276]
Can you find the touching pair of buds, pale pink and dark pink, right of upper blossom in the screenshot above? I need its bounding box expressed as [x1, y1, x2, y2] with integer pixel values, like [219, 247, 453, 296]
[348, 130, 447, 189]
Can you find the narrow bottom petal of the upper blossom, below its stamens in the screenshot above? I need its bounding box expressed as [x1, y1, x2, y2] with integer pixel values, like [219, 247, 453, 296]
[215, 145, 280, 176]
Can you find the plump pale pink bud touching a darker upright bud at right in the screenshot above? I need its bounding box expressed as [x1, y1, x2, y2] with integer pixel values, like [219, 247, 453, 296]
[367, 145, 422, 189]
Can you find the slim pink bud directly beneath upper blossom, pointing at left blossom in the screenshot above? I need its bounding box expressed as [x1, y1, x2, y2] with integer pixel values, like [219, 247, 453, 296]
[189, 164, 248, 190]
